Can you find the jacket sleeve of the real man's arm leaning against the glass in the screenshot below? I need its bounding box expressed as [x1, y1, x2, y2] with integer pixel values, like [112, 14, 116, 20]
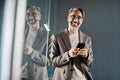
[49, 35, 70, 67]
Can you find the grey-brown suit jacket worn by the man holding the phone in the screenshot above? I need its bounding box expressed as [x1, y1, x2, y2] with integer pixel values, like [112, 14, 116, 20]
[50, 29, 93, 80]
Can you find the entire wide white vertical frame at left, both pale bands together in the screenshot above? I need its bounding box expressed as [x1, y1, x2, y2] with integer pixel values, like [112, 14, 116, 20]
[0, 0, 27, 80]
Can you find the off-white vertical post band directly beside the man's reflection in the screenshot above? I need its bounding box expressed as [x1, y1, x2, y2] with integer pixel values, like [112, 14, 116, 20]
[11, 0, 27, 80]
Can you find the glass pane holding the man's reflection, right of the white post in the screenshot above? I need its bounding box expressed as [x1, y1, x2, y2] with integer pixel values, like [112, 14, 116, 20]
[21, 0, 51, 80]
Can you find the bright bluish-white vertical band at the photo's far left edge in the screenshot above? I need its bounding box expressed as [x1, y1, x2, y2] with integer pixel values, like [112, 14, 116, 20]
[0, 0, 16, 80]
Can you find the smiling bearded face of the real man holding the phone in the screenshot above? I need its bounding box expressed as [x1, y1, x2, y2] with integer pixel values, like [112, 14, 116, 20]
[68, 10, 83, 29]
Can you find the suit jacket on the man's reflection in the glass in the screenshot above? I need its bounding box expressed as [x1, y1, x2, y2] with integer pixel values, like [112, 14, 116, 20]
[21, 27, 49, 80]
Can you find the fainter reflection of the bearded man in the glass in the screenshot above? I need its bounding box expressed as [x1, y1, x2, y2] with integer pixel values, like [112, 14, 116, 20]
[21, 6, 49, 80]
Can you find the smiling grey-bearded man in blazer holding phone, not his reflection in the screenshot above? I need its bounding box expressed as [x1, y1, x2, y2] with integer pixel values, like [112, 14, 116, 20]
[50, 8, 93, 80]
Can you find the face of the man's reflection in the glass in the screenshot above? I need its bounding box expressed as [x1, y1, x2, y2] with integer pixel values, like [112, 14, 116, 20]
[26, 8, 41, 25]
